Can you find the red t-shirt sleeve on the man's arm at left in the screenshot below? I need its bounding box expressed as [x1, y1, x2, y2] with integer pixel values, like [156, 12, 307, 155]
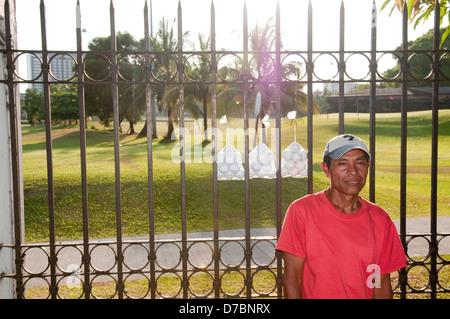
[276, 202, 306, 258]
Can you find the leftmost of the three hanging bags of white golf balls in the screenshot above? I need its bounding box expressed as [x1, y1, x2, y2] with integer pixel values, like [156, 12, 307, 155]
[217, 144, 244, 180]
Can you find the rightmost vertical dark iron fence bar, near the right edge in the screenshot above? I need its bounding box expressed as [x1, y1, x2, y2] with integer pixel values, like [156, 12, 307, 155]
[430, 1, 441, 299]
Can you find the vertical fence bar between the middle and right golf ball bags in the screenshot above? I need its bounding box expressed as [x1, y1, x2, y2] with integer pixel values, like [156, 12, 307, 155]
[275, 1, 284, 298]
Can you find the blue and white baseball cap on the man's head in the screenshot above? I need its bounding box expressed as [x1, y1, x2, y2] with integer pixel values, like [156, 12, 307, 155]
[323, 134, 370, 162]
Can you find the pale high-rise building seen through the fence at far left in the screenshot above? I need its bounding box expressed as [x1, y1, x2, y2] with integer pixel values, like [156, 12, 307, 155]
[28, 53, 75, 92]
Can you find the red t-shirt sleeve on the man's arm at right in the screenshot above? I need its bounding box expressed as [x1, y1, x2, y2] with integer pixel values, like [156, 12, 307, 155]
[379, 219, 407, 274]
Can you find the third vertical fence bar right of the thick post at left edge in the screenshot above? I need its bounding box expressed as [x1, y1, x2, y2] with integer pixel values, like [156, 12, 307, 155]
[110, 0, 124, 299]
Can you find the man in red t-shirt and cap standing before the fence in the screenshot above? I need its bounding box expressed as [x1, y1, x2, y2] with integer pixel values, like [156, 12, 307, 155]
[277, 134, 406, 299]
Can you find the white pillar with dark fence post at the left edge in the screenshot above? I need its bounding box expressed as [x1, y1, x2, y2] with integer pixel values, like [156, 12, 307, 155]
[0, 0, 23, 299]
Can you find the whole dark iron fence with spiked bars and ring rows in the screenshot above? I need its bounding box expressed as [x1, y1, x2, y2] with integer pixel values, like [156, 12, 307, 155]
[0, 1, 450, 299]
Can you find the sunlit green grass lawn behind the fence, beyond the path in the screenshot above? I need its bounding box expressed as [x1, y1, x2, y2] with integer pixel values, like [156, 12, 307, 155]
[22, 110, 450, 242]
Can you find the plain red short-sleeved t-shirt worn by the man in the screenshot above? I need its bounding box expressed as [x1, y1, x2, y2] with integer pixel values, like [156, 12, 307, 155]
[276, 191, 406, 299]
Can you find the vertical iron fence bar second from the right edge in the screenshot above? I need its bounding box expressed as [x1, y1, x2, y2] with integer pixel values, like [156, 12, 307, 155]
[399, 1, 408, 298]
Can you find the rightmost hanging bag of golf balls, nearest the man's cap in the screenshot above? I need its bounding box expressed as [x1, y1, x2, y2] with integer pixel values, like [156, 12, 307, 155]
[281, 142, 308, 177]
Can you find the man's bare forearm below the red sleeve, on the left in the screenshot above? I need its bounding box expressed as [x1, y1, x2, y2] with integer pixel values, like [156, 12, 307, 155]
[283, 252, 305, 299]
